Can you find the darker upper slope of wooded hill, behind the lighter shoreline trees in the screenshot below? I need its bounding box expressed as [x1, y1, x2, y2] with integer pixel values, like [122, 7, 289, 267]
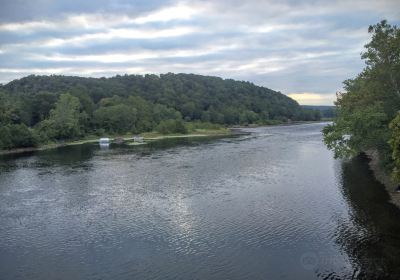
[4, 73, 304, 121]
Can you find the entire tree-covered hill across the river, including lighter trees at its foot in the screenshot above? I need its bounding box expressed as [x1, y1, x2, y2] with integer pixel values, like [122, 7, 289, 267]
[0, 73, 320, 148]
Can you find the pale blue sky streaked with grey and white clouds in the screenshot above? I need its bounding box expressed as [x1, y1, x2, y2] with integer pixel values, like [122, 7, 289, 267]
[0, 0, 400, 105]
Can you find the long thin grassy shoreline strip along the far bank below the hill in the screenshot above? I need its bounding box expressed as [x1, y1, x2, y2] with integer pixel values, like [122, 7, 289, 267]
[0, 120, 330, 155]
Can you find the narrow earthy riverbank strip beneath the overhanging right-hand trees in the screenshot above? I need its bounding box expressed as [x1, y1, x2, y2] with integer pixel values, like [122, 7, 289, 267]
[364, 150, 400, 208]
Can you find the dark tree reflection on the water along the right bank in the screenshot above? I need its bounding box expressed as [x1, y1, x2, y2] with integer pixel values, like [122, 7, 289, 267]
[337, 157, 400, 279]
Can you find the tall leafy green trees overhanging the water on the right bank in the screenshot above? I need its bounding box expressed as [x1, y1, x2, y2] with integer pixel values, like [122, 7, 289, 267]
[324, 20, 400, 183]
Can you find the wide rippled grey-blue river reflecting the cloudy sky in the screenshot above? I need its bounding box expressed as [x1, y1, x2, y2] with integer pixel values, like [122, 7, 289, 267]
[0, 124, 400, 279]
